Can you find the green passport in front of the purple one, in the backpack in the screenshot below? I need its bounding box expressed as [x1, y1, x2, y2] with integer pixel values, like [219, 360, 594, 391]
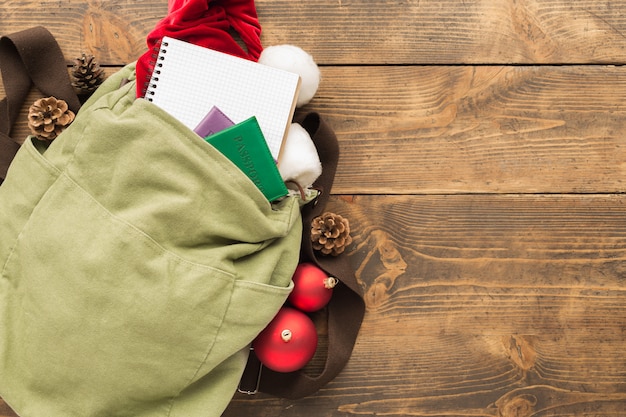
[204, 116, 288, 201]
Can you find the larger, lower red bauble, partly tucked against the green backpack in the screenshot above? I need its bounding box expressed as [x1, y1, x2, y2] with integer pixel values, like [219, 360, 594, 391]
[252, 307, 317, 372]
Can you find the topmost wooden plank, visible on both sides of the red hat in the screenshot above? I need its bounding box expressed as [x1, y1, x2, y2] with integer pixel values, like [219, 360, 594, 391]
[0, 0, 626, 65]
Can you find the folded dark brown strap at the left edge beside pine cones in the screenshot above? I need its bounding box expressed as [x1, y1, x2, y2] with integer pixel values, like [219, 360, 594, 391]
[0, 26, 80, 183]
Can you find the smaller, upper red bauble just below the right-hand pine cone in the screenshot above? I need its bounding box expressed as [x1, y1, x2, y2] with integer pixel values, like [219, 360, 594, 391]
[287, 262, 337, 312]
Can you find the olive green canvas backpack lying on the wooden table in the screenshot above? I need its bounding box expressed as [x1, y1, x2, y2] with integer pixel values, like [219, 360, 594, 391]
[0, 55, 302, 417]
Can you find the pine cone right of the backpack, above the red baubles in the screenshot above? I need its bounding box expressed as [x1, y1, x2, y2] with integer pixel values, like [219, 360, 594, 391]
[311, 212, 352, 256]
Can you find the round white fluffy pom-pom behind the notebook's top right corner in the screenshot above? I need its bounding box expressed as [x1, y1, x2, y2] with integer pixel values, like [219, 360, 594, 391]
[259, 45, 321, 107]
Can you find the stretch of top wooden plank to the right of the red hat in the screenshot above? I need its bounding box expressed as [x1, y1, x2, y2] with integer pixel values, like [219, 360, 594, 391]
[257, 0, 626, 64]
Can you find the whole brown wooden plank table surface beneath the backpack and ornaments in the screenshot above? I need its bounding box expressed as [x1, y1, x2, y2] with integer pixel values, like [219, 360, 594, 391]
[0, 0, 626, 417]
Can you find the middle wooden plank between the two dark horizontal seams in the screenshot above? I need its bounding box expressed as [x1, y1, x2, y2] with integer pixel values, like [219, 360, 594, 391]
[0, 66, 626, 194]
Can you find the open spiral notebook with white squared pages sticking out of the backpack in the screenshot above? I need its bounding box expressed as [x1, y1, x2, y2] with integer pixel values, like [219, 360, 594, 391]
[145, 36, 300, 161]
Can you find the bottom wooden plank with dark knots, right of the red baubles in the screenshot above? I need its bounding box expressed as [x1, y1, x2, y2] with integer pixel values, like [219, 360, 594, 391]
[225, 195, 626, 417]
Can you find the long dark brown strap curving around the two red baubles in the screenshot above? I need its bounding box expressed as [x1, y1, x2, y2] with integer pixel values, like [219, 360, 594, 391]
[242, 113, 365, 399]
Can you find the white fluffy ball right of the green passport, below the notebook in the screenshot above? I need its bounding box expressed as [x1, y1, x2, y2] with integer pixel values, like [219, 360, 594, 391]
[278, 123, 322, 188]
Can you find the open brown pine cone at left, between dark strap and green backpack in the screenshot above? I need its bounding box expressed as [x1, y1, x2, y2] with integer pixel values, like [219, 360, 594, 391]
[28, 97, 74, 141]
